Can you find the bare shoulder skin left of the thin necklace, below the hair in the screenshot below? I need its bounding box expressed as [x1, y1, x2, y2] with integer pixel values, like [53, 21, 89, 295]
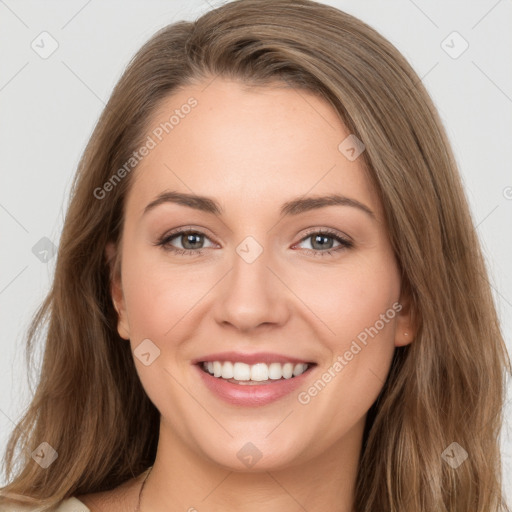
[76, 476, 142, 512]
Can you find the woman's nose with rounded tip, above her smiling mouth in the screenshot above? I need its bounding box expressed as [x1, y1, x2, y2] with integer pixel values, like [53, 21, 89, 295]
[215, 243, 291, 332]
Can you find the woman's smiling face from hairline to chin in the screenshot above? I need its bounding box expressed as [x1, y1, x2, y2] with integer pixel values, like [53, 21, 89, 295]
[110, 77, 412, 470]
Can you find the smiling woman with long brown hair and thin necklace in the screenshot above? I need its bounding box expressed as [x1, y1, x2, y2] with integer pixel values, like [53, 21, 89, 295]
[0, 0, 510, 512]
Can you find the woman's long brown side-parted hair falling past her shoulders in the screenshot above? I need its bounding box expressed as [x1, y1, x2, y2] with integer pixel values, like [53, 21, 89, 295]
[0, 0, 511, 512]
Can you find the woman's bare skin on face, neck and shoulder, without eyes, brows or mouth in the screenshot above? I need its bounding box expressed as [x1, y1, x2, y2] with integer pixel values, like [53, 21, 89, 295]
[81, 77, 414, 512]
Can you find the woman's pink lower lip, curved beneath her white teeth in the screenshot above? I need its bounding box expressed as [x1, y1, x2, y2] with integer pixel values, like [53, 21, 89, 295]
[194, 364, 314, 407]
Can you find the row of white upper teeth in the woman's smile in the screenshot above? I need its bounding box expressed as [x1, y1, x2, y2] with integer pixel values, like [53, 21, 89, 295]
[203, 361, 309, 381]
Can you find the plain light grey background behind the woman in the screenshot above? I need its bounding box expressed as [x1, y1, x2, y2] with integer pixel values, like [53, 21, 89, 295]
[0, 0, 512, 501]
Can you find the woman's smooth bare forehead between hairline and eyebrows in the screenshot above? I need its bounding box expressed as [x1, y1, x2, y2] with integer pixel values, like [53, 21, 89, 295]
[123, 77, 380, 220]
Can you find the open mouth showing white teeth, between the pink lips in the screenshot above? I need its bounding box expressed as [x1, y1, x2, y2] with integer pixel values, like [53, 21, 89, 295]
[197, 361, 316, 386]
